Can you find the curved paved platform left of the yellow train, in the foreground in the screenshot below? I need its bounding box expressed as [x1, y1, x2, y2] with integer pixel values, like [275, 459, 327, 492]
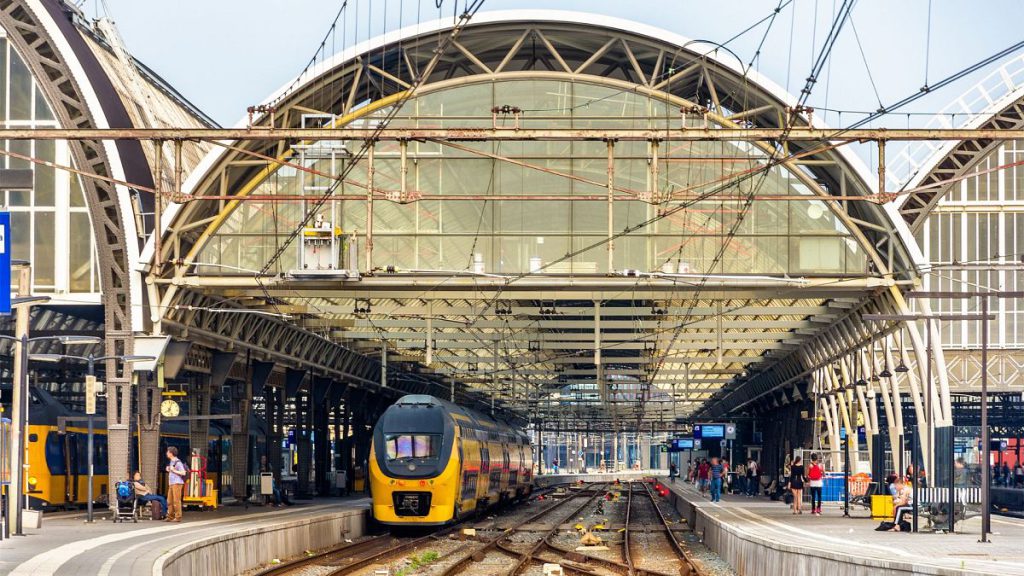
[0, 496, 370, 576]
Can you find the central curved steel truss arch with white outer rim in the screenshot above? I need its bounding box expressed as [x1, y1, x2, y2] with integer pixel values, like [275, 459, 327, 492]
[155, 10, 925, 278]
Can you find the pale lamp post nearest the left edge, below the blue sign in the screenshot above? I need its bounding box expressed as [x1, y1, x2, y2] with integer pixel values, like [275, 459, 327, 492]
[0, 307, 99, 536]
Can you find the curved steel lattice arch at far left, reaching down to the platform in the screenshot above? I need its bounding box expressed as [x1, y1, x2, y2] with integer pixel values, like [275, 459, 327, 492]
[0, 0, 148, 478]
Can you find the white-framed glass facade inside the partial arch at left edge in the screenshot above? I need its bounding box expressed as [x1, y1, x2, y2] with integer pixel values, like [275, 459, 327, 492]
[0, 29, 99, 294]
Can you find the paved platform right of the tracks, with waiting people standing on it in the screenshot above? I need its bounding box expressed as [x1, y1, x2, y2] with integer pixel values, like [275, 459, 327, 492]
[663, 479, 1024, 576]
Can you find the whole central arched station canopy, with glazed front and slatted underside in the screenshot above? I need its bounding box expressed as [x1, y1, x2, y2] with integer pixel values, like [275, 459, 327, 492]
[145, 10, 922, 429]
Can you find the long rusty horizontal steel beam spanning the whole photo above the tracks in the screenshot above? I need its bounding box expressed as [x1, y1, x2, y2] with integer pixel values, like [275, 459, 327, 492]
[0, 127, 1024, 142]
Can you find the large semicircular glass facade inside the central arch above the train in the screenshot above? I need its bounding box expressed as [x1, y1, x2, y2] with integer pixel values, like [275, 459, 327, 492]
[200, 79, 866, 276]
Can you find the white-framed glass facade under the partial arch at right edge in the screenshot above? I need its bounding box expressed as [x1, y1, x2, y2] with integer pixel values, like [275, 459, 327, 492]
[918, 140, 1024, 348]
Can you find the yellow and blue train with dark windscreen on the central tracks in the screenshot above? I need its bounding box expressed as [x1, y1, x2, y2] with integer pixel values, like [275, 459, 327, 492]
[370, 395, 534, 526]
